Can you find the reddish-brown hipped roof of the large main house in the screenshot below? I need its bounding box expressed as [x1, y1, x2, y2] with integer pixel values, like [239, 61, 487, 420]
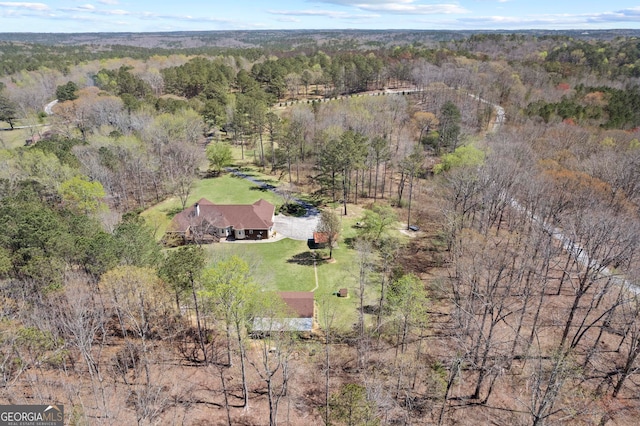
[170, 198, 275, 231]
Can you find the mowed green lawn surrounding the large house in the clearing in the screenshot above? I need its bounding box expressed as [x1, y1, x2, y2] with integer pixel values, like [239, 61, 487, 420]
[143, 168, 377, 332]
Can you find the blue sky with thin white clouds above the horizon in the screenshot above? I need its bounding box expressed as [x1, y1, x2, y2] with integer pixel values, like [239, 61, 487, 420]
[0, 0, 640, 32]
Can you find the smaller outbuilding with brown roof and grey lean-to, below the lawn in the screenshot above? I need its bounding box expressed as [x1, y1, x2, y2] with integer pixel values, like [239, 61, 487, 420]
[252, 291, 316, 336]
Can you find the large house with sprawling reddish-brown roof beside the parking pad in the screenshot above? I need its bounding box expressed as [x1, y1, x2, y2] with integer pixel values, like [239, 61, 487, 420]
[167, 198, 275, 242]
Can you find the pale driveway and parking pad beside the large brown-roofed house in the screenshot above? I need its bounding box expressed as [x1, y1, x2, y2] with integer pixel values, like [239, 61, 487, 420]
[226, 167, 320, 241]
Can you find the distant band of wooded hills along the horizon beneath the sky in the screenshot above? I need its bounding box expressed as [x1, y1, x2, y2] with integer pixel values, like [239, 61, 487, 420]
[0, 30, 640, 77]
